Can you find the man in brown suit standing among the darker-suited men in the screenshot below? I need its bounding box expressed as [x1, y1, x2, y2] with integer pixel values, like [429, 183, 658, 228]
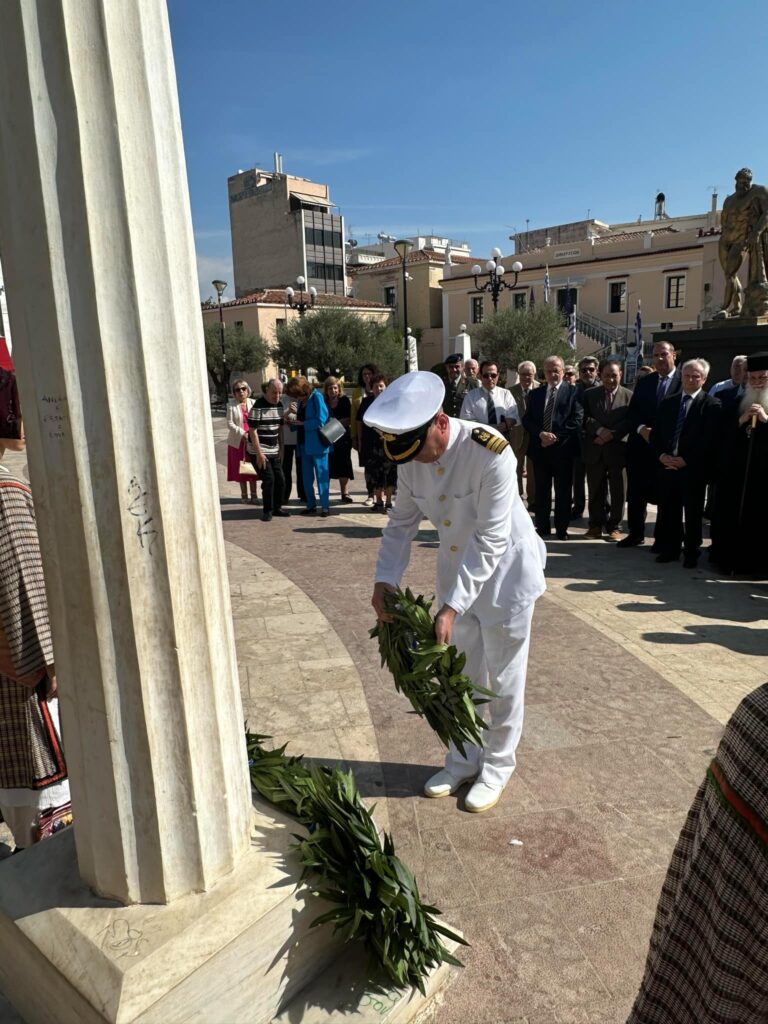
[582, 359, 632, 541]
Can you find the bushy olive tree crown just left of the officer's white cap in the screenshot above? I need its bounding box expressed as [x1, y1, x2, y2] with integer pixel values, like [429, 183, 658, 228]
[275, 308, 402, 383]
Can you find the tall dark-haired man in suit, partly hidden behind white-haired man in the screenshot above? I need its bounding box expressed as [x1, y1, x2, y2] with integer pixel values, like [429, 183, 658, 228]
[616, 341, 680, 551]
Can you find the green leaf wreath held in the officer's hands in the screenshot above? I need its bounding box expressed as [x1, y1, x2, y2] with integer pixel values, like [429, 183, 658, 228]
[371, 589, 494, 754]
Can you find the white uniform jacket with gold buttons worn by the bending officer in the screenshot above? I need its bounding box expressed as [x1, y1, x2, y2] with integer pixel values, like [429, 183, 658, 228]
[376, 418, 547, 626]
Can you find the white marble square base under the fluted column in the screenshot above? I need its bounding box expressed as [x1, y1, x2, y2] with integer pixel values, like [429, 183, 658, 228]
[0, 803, 456, 1024]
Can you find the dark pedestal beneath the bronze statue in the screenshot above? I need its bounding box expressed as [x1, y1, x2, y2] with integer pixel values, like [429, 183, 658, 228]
[653, 316, 768, 386]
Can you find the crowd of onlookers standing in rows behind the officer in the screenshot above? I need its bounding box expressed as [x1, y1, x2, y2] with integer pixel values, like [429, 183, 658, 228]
[227, 341, 768, 574]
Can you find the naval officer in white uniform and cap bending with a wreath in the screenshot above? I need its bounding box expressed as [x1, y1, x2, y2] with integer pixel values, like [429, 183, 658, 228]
[364, 371, 546, 812]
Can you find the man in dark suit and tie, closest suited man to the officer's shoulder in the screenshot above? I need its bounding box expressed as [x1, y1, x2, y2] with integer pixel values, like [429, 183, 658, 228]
[522, 355, 584, 541]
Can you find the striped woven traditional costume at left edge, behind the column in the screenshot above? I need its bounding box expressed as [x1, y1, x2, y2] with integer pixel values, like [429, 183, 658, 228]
[0, 467, 70, 847]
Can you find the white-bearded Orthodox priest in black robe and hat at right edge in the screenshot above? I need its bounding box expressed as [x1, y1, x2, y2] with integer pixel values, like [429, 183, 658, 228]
[712, 352, 768, 579]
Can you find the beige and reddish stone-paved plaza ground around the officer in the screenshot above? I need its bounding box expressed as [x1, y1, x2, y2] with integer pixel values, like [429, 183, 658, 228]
[0, 419, 768, 1024]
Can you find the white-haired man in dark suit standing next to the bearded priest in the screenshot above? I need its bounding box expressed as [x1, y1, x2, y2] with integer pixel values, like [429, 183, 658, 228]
[650, 359, 721, 569]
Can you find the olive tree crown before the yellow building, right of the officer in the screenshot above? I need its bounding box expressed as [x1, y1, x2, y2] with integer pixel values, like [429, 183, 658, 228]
[472, 302, 573, 374]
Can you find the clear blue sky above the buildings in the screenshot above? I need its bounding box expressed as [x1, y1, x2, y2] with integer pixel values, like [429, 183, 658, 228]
[169, 0, 768, 297]
